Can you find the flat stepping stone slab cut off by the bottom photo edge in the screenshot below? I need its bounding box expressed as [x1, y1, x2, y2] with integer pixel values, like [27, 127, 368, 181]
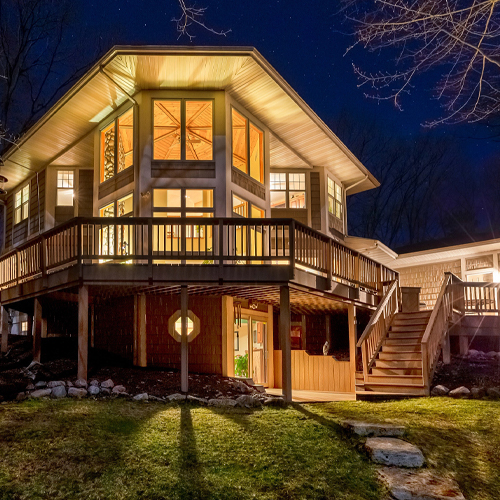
[379, 467, 465, 500]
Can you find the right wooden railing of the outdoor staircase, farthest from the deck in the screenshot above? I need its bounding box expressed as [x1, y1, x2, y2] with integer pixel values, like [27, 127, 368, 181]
[421, 273, 455, 391]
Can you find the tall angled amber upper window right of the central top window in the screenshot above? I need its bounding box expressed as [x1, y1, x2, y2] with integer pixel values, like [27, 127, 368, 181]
[231, 109, 264, 184]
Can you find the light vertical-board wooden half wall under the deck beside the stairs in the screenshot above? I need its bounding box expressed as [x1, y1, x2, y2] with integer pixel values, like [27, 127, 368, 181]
[274, 351, 355, 392]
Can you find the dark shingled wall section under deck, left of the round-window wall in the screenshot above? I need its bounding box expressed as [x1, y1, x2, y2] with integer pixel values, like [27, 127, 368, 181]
[94, 296, 134, 360]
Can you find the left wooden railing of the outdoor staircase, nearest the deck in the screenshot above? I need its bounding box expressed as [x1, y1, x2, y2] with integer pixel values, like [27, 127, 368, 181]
[356, 280, 400, 382]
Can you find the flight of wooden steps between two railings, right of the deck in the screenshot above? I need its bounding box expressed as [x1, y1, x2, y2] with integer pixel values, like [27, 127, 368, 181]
[356, 311, 431, 399]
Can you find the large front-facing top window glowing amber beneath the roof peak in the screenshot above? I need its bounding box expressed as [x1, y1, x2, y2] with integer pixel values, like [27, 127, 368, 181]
[153, 99, 213, 161]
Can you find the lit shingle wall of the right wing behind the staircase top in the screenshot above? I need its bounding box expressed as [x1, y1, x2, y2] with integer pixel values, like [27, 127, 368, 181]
[398, 260, 461, 309]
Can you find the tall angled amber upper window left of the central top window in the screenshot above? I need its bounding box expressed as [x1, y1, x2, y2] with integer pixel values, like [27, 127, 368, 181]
[101, 108, 134, 182]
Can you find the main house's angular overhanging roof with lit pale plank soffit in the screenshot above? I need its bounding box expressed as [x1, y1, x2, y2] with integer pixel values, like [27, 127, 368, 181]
[2, 46, 379, 194]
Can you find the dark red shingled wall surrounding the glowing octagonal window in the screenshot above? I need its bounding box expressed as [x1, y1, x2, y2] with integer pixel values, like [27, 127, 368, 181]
[146, 295, 222, 374]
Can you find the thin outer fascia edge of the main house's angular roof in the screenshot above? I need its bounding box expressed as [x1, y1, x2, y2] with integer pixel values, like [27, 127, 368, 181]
[3, 45, 380, 187]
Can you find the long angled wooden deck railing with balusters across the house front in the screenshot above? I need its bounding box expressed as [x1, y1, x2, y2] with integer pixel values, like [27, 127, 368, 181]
[0, 217, 397, 295]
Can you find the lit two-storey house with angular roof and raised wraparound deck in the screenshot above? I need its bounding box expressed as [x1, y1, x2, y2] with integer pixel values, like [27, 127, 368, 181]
[0, 46, 412, 399]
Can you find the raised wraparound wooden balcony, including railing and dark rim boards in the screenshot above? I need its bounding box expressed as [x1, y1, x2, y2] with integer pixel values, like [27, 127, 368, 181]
[0, 217, 397, 305]
